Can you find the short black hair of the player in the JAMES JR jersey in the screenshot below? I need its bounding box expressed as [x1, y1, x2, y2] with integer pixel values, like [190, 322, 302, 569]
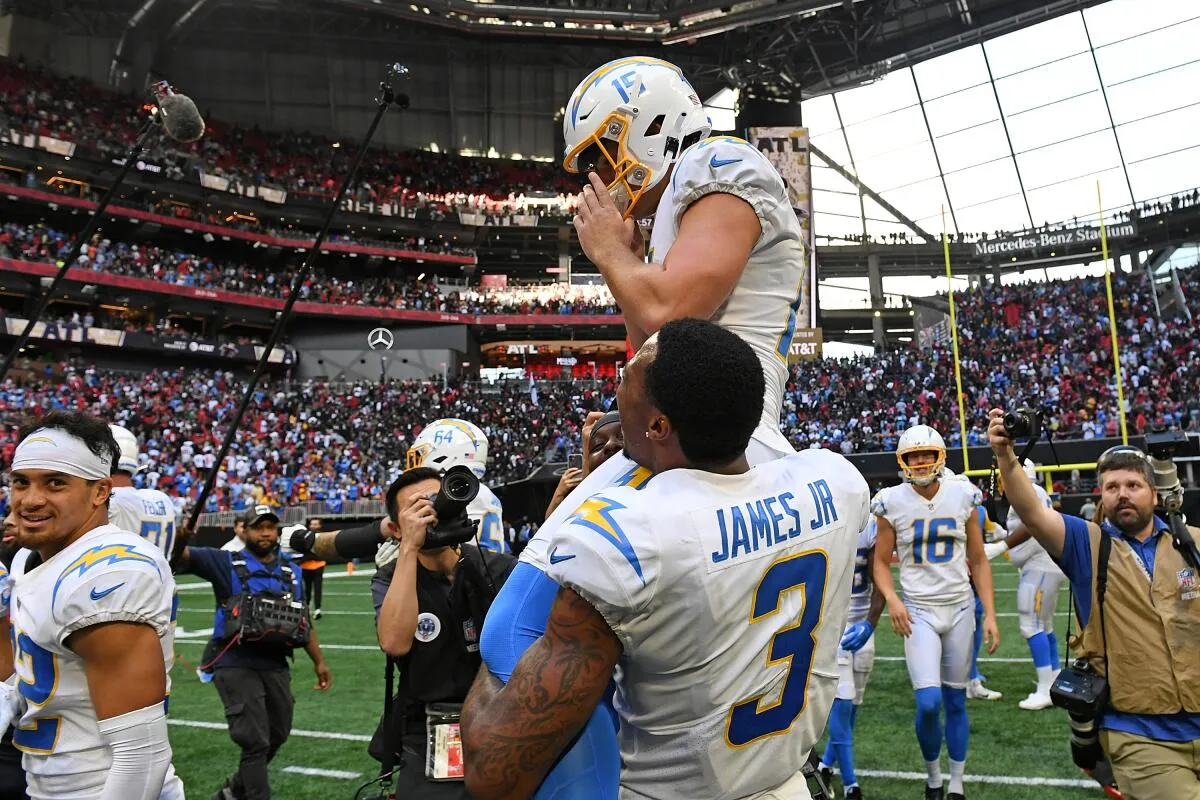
[646, 319, 767, 465]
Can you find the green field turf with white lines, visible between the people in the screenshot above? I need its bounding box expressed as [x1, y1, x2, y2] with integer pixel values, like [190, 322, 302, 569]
[170, 560, 1103, 800]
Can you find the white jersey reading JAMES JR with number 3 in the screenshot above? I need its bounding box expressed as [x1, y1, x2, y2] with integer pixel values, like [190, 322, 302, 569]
[546, 450, 869, 800]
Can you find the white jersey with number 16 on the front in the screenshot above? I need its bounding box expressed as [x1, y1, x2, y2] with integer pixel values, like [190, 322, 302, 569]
[871, 480, 983, 606]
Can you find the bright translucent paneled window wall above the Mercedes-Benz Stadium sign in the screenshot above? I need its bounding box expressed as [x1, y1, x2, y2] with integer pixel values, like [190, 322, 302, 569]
[802, 0, 1200, 247]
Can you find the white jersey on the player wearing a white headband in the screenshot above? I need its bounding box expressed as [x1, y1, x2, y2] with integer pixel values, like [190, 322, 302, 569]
[10, 525, 175, 800]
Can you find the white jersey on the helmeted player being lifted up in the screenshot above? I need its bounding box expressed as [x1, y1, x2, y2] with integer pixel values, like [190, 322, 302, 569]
[649, 136, 809, 450]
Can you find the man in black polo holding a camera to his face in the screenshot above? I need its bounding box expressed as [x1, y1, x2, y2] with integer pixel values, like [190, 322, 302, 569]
[371, 467, 516, 800]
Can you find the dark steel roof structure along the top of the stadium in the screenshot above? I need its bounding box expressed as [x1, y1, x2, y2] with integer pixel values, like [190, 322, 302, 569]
[30, 0, 1100, 97]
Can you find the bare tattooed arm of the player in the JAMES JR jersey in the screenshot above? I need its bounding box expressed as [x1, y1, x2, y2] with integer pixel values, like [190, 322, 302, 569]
[462, 588, 622, 800]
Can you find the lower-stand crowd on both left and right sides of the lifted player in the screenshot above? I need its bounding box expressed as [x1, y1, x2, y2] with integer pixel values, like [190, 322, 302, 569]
[0, 262, 1200, 509]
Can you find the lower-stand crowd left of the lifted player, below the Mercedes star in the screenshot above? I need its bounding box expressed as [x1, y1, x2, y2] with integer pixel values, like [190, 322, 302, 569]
[0, 363, 616, 510]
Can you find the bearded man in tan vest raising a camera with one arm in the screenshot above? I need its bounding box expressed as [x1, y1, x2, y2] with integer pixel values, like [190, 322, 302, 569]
[988, 409, 1200, 800]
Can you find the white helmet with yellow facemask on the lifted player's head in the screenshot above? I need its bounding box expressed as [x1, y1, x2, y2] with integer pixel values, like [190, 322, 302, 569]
[563, 56, 713, 217]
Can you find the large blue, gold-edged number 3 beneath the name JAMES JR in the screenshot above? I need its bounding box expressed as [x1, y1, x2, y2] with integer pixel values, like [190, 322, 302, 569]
[725, 551, 828, 747]
